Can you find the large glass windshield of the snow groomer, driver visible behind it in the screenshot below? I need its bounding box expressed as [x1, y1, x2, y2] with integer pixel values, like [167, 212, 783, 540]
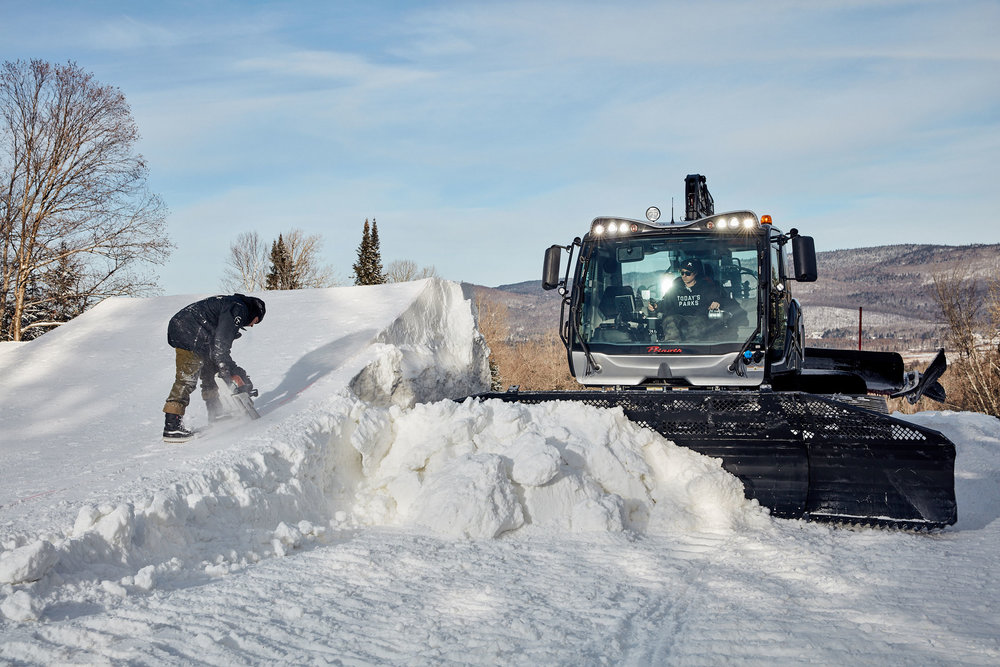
[578, 235, 760, 353]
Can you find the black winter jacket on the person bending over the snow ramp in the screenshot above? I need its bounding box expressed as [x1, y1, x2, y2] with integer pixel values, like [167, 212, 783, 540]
[167, 294, 251, 376]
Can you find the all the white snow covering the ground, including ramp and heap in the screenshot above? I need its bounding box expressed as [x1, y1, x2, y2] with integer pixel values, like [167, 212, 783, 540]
[0, 279, 1000, 665]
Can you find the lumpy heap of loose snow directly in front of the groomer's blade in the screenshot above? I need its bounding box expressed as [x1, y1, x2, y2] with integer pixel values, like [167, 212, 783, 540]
[334, 400, 766, 538]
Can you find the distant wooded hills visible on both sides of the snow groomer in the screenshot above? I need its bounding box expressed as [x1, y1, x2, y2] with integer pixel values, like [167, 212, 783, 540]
[464, 244, 1000, 351]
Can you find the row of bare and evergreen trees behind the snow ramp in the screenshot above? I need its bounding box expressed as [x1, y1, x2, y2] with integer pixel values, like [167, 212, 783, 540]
[0, 60, 435, 341]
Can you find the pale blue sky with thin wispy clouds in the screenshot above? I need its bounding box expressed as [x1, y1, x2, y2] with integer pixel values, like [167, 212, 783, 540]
[0, 0, 1000, 294]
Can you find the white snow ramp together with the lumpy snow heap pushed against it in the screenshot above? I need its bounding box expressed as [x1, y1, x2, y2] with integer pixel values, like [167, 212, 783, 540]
[0, 280, 768, 621]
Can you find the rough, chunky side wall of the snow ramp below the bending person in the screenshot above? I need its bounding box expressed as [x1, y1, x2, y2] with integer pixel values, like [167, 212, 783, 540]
[0, 280, 488, 620]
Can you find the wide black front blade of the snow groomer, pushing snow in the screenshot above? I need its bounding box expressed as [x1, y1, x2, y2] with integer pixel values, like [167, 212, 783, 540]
[475, 390, 957, 528]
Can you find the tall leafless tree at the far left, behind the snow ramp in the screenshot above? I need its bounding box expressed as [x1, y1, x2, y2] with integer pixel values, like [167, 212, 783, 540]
[0, 60, 172, 340]
